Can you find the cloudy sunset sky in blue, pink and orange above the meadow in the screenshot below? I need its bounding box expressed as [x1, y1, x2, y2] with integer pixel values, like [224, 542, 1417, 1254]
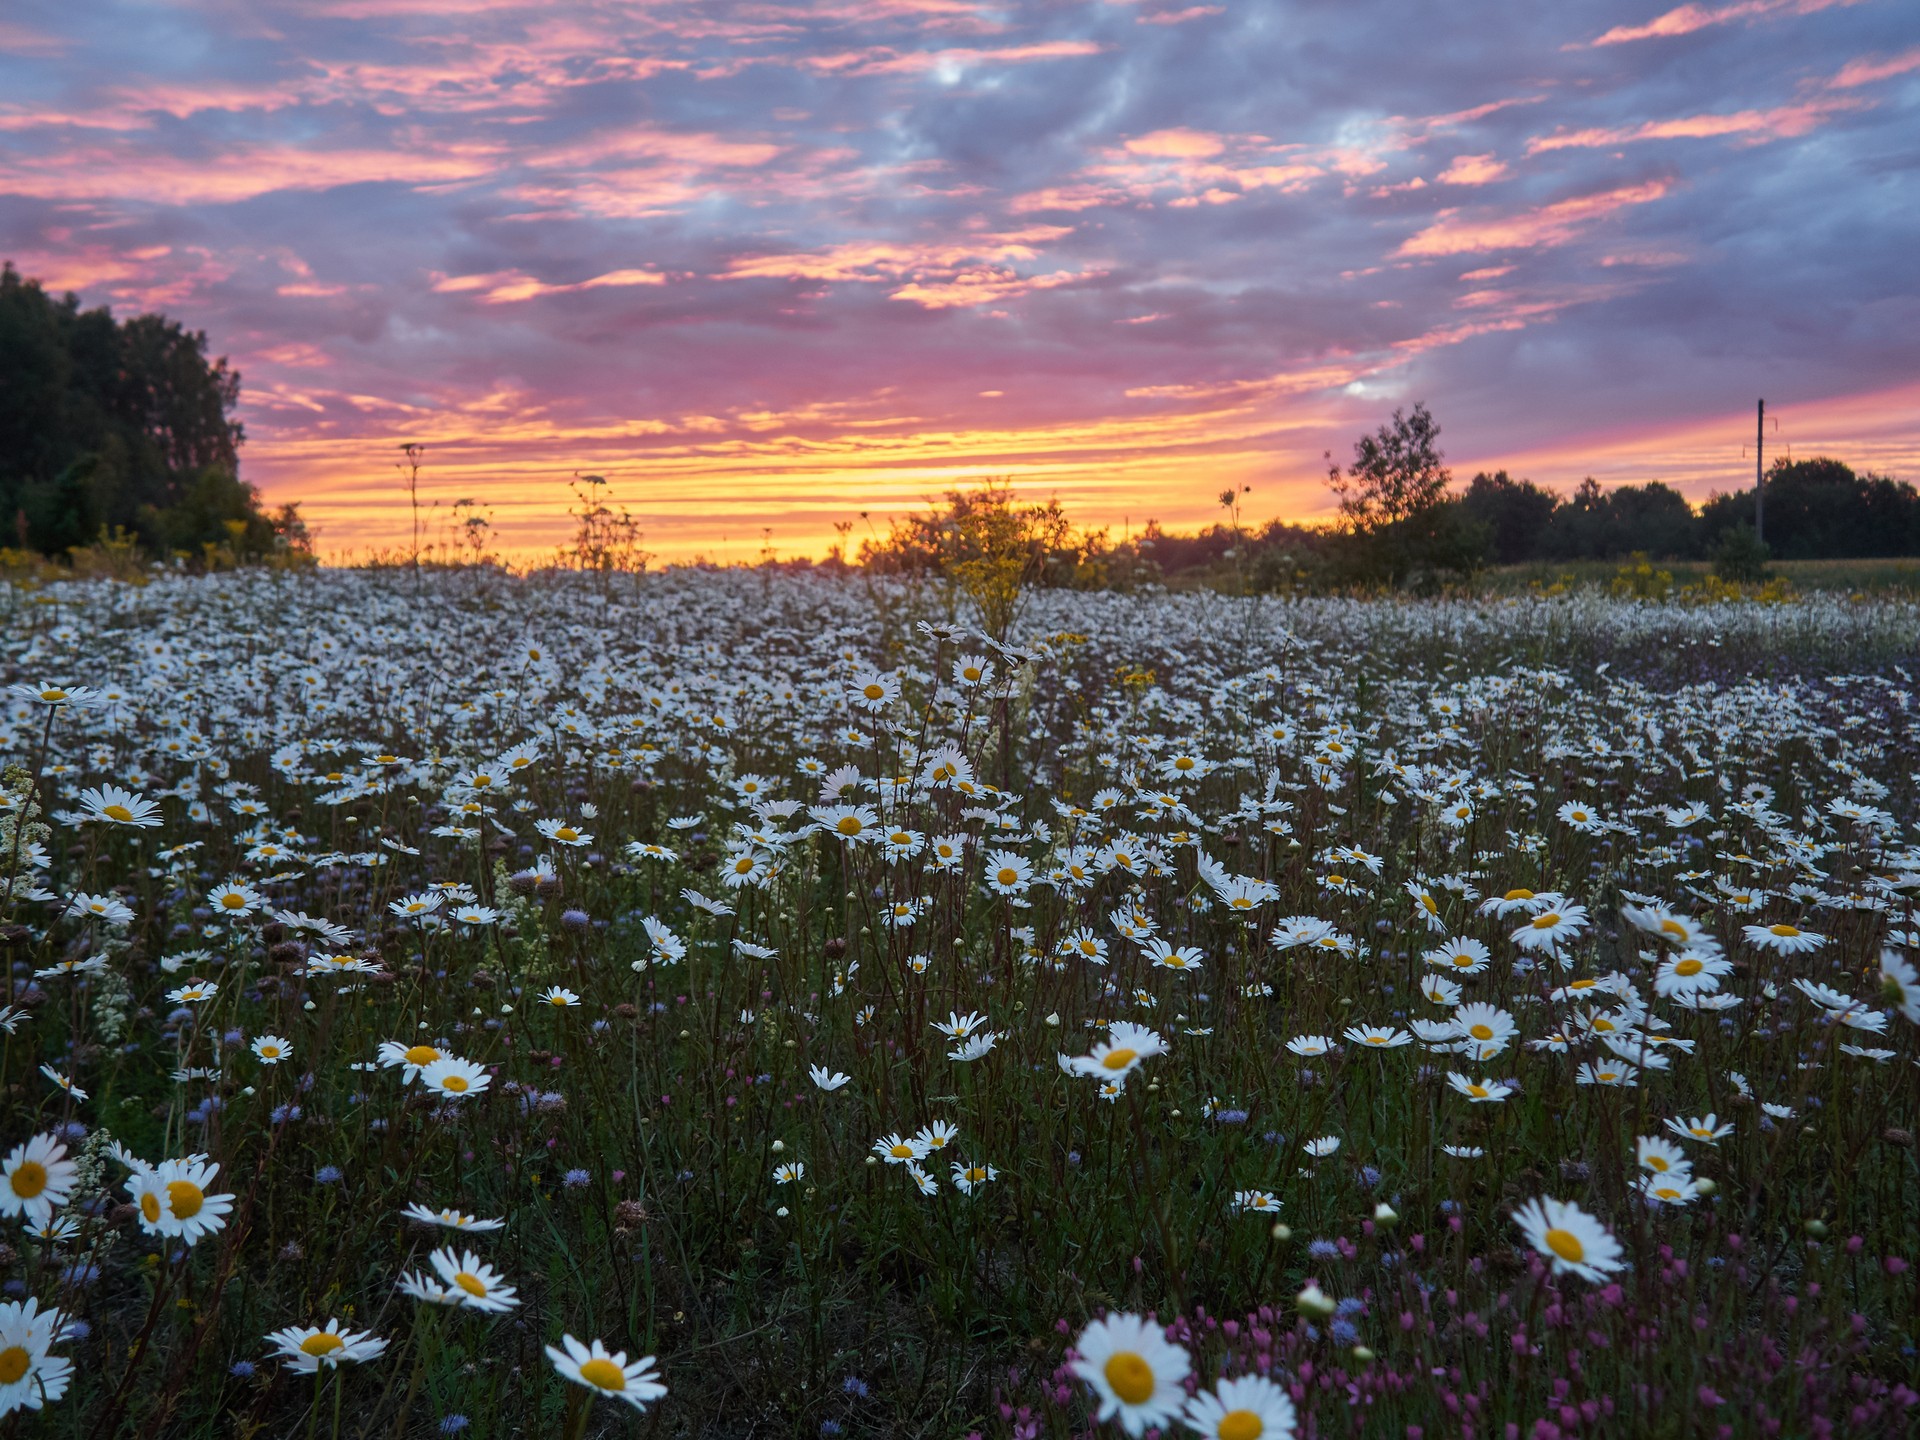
[0, 0, 1920, 561]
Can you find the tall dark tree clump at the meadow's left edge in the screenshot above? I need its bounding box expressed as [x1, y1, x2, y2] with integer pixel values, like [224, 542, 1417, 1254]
[0, 263, 307, 563]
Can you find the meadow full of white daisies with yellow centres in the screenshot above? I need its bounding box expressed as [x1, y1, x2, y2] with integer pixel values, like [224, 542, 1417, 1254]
[0, 566, 1920, 1440]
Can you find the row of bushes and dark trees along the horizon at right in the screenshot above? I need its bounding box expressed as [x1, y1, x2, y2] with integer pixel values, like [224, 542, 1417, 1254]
[860, 405, 1920, 612]
